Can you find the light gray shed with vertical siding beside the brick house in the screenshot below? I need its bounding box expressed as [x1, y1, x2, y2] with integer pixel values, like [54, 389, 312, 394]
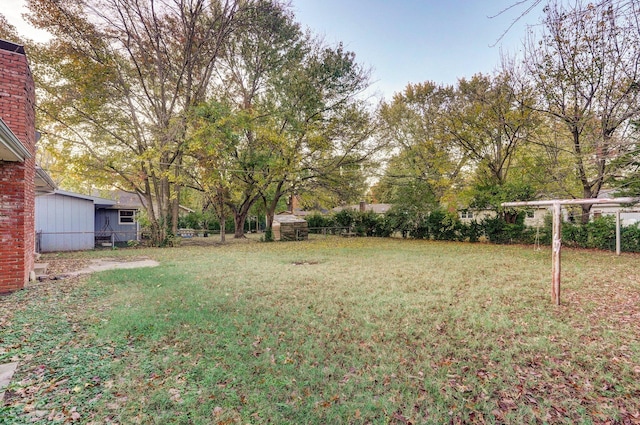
[35, 190, 115, 252]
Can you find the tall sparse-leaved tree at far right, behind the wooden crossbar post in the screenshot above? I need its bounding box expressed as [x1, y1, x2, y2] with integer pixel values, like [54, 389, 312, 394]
[525, 1, 640, 222]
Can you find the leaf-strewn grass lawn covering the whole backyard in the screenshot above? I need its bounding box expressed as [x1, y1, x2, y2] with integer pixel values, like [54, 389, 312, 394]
[0, 238, 640, 424]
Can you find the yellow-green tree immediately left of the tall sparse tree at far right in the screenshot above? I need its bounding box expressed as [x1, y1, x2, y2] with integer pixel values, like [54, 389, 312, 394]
[443, 71, 537, 222]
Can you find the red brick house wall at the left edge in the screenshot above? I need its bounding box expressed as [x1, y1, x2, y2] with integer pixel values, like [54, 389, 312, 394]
[0, 43, 36, 293]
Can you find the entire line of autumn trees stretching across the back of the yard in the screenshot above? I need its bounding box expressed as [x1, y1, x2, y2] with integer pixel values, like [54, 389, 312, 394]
[6, 0, 640, 245]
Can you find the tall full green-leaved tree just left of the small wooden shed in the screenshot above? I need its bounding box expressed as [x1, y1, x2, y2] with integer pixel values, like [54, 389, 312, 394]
[189, 7, 376, 237]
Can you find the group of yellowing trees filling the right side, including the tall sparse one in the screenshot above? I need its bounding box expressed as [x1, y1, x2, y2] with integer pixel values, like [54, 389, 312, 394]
[372, 1, 640, 224]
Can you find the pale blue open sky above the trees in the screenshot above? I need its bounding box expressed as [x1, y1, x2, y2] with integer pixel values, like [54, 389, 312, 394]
[0, 0, 542, 100]
